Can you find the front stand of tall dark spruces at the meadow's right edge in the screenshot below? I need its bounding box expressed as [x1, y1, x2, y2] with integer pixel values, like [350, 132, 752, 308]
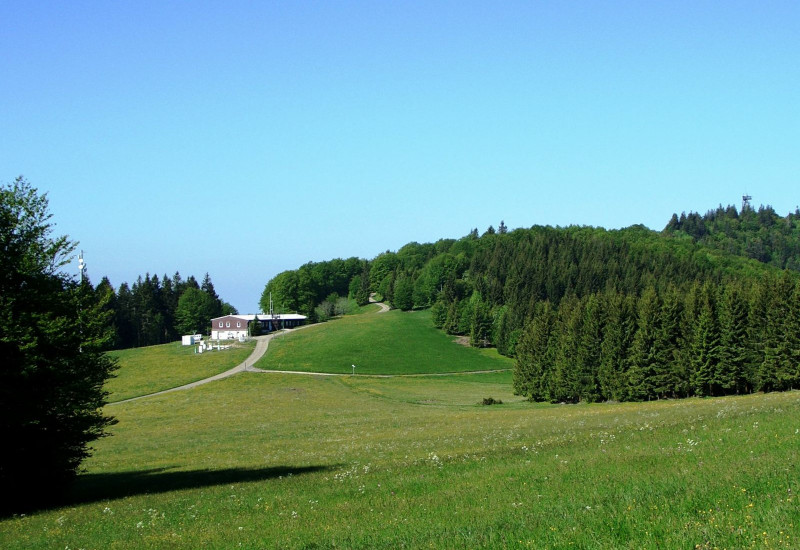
[514, 278, 800, 403]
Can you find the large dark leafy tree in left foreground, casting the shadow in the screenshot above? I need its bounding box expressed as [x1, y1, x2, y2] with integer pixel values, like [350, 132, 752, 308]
[0, 177, 116, 513]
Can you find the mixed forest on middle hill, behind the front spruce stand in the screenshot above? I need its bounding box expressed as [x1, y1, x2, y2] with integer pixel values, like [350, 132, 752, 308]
[261, 222, 760, 344]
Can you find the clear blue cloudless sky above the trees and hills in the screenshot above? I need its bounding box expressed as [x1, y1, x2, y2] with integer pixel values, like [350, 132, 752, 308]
[0, 0, 800, 313]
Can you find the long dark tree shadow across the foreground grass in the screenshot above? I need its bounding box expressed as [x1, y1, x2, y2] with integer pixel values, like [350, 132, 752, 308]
[0, 465, 337, 517]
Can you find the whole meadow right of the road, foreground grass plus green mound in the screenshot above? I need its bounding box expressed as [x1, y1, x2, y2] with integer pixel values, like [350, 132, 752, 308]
[0, 312, 800, 549]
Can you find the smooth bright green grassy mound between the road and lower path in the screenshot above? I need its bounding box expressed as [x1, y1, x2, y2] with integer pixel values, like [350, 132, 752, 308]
[256, 310, 513, 374]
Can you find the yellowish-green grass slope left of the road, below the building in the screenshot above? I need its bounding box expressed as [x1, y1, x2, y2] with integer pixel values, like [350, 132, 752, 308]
[106, 342, 255, 402]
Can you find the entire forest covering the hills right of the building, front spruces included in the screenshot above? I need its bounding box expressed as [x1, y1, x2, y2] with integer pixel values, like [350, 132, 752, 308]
[261, 206, 800, 403]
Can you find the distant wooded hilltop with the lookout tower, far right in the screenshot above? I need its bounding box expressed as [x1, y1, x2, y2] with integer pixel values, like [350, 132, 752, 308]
[664, 206, 800, 271]
